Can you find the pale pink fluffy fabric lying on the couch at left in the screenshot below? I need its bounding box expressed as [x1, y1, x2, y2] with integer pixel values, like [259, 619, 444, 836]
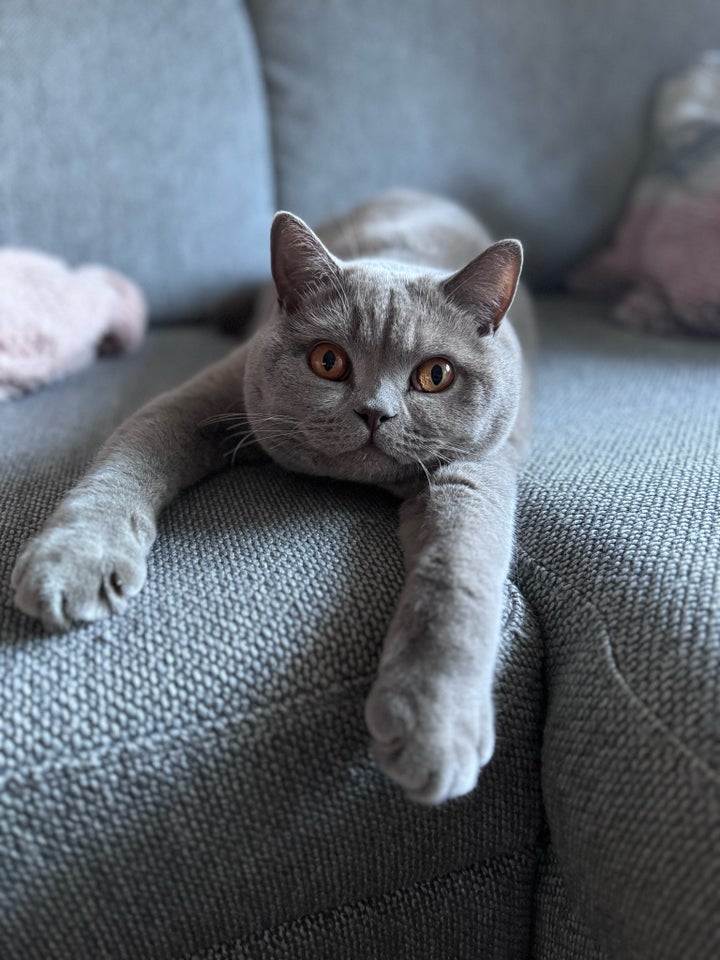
[0, 247, 147, 400]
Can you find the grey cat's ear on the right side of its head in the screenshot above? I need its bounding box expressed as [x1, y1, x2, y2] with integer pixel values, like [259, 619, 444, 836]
[442, 240, 523, 336]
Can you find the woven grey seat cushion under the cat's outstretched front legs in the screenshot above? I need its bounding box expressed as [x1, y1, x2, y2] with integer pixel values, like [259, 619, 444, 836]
[0, 329, 542, 960]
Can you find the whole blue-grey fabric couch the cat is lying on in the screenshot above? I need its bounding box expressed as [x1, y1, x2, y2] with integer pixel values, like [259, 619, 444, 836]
[0, 0, 720, 960]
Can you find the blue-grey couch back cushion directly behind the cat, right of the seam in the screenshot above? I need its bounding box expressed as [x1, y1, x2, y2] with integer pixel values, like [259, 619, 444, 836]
[249, 0, 720, 281]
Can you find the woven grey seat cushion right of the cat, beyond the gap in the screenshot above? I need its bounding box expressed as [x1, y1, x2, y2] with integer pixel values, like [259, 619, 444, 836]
[516, 301, 720, 960]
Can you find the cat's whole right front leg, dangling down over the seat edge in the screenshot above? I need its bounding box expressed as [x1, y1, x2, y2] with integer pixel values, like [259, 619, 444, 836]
[365, 450, 517, 803]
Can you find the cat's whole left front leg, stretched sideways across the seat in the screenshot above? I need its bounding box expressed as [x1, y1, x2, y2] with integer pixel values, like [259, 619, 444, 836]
[12, 346, 246, 630]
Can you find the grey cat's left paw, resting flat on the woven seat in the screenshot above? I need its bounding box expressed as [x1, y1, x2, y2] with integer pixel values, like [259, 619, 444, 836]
[11, 522, 146, 631]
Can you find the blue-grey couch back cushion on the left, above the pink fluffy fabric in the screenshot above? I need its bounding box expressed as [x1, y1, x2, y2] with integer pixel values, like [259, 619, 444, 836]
[0, 0, 274, 317]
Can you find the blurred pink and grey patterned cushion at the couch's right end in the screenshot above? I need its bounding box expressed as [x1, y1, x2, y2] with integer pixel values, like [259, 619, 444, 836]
[569, 53, 720, 336]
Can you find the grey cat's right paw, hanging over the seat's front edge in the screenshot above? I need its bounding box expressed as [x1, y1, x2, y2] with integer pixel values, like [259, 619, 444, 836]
[365, 658, 495, 804]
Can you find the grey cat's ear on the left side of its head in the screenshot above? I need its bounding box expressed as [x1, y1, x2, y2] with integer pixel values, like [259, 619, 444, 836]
[270, 210, 342, 313]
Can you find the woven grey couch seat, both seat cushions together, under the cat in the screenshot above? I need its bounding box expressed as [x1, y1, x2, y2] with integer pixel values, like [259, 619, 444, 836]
[0, 301, 720, 960]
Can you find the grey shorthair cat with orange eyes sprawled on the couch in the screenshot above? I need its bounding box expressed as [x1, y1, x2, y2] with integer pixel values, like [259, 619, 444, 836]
[12, 191, 532, 804]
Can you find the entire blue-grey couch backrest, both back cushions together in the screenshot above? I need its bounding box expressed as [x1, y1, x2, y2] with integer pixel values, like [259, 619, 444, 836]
[0, 0, 720, 316]
